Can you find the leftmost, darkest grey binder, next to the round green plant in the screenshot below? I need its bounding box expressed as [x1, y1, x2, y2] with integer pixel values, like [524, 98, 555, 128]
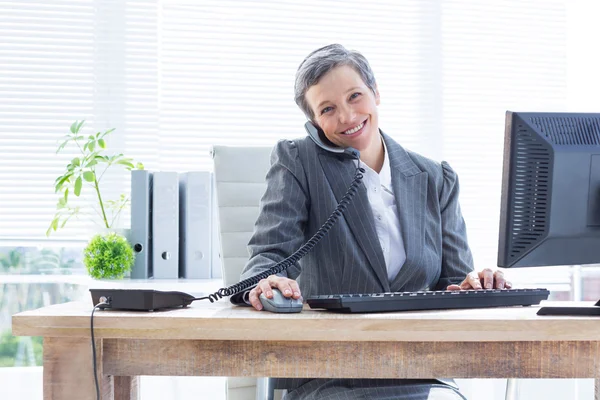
[130, 169, 152, 279]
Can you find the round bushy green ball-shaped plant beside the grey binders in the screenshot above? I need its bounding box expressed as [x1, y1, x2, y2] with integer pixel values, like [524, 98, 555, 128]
[83, 232, 135, 279]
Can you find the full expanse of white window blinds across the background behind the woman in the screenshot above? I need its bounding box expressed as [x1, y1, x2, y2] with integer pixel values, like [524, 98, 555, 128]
[0, 0, 600, 288]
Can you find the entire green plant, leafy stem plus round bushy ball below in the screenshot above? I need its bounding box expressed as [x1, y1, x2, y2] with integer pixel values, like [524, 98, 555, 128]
[46, 121, 144, 278]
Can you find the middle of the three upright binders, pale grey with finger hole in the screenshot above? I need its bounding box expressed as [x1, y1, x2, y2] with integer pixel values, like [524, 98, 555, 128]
[152, 171, 179, 279]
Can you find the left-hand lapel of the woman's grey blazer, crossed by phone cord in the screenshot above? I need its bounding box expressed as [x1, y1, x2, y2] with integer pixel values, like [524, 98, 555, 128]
[319, 153, 390, 292]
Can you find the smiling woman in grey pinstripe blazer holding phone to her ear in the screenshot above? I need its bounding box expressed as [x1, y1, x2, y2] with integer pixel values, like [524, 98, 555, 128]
[242, 44, 476, 400]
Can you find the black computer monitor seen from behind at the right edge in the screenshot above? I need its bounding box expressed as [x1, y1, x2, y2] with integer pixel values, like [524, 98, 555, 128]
[498, 111, 600, 316]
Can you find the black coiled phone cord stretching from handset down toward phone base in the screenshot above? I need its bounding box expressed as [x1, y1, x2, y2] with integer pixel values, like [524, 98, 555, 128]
[196, 159, 365, 303]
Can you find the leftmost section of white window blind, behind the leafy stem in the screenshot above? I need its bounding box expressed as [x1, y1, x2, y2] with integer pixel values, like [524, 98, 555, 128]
[0, 1, 96, 238]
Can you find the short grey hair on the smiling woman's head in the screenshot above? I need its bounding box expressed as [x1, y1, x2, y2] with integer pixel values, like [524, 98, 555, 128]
[294, 44, 377, 120]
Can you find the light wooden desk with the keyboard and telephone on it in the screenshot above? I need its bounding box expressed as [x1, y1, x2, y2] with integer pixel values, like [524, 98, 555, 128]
[13, 300, 600, 400]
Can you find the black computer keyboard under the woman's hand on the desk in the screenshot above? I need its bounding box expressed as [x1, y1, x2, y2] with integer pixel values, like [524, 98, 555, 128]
[307, 289, 550, 313]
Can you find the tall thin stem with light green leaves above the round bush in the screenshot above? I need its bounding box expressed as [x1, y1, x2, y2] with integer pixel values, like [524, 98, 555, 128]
[46, 121, 144, 236]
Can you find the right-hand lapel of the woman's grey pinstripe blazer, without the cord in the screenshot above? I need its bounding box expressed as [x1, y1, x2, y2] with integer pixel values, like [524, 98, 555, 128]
[382, 132, 427, 290]
